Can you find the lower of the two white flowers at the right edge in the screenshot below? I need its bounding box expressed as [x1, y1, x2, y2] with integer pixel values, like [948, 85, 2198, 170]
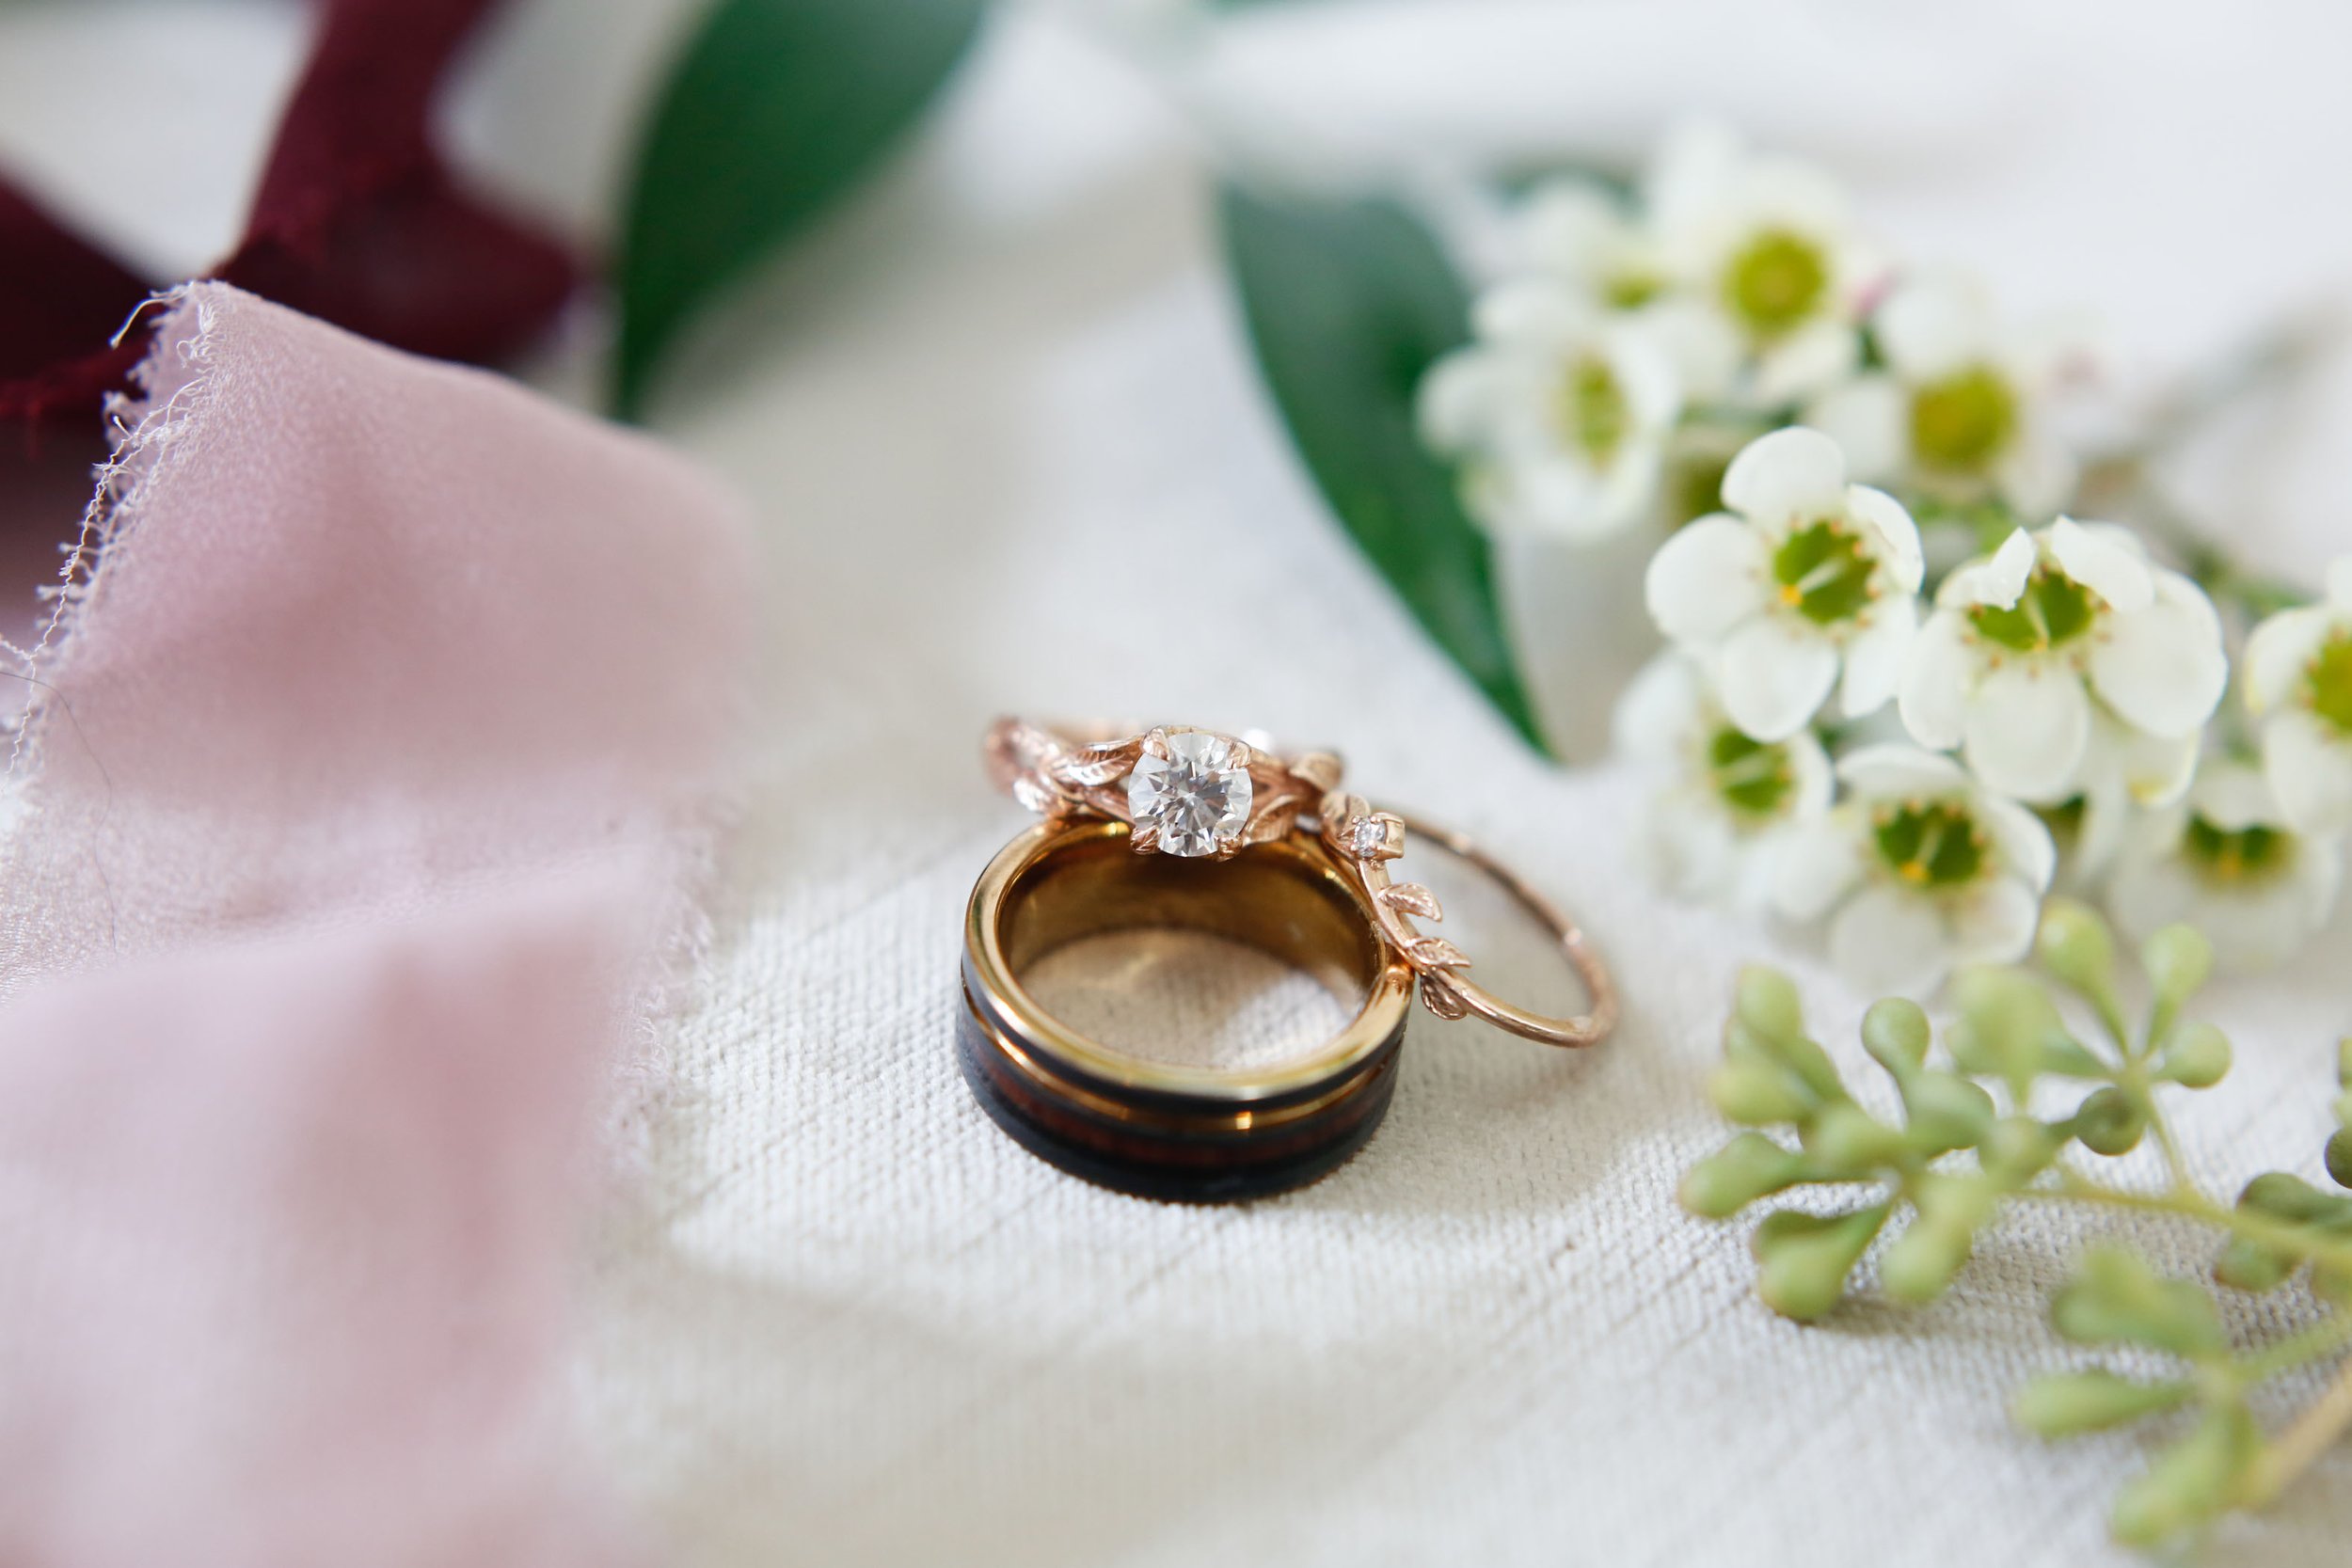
[2107, 762, 2343, 971]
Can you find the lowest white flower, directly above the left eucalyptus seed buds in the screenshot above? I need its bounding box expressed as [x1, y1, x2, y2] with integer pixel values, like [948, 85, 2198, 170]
[1773, 745, 2056, 994]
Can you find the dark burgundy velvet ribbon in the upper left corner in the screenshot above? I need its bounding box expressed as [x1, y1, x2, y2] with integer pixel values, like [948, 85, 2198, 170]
[0, 0, 579, 428]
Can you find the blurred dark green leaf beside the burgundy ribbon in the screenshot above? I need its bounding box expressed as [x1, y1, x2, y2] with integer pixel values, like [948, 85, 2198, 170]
[614, 0, 986, 419]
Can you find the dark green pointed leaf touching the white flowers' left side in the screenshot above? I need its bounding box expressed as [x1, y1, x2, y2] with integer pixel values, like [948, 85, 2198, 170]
[1221, 183, 1543, 750]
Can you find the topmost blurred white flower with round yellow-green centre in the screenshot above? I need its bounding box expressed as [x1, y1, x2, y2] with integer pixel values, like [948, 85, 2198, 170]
[1645, 129, 1877, 406]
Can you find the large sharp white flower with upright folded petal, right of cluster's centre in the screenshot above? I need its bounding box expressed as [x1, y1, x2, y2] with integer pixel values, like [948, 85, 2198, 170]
[1900, 517, 2230, 804]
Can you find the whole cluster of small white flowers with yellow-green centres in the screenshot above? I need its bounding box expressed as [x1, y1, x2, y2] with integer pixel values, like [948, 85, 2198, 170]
[1423, 134, 2352, 992]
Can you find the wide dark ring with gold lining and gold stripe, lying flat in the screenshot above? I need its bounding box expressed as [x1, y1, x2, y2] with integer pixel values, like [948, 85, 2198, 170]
[960, 818, 1414, 1199]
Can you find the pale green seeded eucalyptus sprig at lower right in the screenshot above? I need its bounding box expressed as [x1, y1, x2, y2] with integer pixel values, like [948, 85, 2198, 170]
[1682, 900, 2352, 1547]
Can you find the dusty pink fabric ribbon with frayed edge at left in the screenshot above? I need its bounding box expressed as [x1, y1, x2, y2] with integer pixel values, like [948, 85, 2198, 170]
[0, 284, 751, 1568]
